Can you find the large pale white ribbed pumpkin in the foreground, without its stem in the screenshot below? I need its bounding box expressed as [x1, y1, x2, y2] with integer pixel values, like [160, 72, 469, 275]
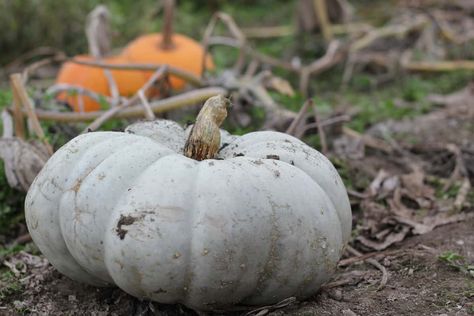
[25, 98, 351, 310]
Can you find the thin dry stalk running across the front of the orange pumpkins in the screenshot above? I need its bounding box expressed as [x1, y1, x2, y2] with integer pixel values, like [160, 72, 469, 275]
[67, 58, 204, 87]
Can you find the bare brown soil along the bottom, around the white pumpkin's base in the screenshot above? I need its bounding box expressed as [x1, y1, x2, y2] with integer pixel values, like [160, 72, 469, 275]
[0, 220, 474, 315]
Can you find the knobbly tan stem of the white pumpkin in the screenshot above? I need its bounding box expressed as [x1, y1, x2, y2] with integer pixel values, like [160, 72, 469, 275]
[184, 95, 230, 161]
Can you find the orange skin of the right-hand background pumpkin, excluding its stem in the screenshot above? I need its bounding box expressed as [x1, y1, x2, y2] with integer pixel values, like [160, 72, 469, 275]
[121, 33, 214, 90]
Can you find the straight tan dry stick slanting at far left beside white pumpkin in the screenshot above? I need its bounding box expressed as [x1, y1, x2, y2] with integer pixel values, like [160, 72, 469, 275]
[10, 74, 53, 155]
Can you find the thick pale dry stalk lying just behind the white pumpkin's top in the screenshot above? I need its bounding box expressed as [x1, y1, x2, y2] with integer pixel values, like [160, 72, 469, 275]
[22, 87, 228, 123]
